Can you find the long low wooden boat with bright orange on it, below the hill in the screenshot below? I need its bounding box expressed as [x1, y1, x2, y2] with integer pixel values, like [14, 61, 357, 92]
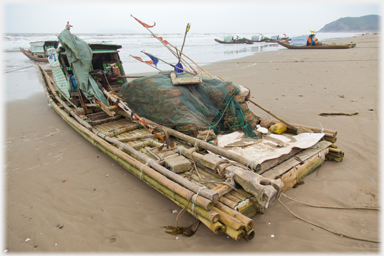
[277, 34, 356, 49]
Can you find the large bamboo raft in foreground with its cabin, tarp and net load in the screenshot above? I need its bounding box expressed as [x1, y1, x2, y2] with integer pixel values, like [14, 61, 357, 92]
[39, 23, 344, 241]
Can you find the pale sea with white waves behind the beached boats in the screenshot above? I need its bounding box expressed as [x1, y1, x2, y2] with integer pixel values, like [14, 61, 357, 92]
[2, 33, 357, 74]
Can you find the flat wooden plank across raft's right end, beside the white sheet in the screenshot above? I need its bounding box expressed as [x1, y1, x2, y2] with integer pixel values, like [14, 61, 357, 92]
[262, 140, 332, 179]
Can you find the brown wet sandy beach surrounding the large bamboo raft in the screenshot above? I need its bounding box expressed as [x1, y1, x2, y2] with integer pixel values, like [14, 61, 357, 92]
[2, 34, 381, 254]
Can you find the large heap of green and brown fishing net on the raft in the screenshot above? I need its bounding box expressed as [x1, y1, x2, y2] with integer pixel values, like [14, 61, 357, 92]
[119, 72, 258, 138]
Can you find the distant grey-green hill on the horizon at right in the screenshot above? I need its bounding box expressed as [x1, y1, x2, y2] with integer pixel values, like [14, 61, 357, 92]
[318, 15, 380, 33]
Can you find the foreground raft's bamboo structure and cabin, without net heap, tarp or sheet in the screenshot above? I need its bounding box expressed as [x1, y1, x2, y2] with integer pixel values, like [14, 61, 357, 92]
[39, 25, 344, 241]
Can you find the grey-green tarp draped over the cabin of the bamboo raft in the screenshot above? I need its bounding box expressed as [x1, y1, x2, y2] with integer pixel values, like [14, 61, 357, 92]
[58, 29, 109, 106]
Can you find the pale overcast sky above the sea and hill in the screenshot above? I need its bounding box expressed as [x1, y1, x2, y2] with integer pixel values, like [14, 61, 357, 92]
[2, 0, 381, 34]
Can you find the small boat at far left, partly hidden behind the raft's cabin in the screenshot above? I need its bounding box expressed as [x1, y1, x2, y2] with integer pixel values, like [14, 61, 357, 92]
[19, 41, 59, 62]
